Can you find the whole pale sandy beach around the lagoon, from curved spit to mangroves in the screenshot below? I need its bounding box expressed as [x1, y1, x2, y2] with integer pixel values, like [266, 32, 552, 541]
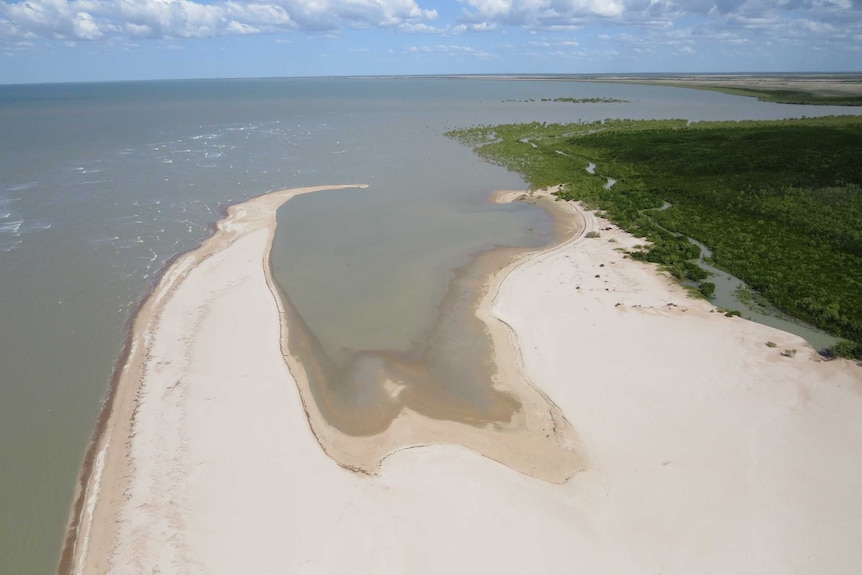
[61, 186, 862, 574]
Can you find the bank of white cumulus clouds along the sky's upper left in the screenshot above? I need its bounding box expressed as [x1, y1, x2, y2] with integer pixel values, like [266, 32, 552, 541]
[0, 0, 437, 40]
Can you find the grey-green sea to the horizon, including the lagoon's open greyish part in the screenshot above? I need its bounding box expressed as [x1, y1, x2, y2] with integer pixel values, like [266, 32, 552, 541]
[0, 78, 853, 573]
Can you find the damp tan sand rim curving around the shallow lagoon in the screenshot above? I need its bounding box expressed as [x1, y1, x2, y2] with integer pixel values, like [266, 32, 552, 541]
[265, 186, 584, 483]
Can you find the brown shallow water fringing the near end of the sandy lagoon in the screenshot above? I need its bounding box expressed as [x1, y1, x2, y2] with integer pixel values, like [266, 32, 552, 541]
[280, 191, 574, 435]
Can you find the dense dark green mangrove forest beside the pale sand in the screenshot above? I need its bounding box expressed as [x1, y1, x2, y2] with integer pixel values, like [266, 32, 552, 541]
[448, 116, 862, 358]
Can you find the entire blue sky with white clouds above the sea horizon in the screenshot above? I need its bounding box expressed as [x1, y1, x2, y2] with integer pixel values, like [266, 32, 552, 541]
[0, 0, 862, 83]
